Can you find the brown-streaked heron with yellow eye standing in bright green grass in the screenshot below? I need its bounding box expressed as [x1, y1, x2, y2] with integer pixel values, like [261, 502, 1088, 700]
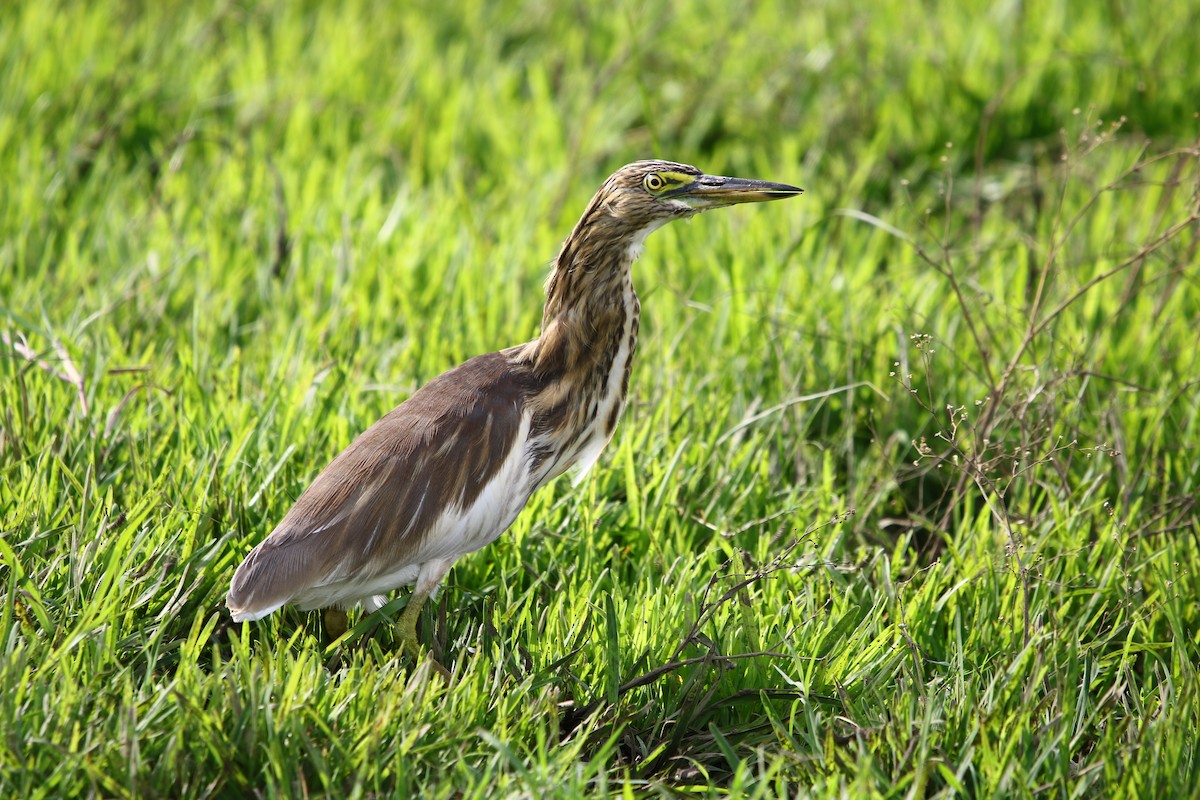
[226, 161, 803, 658]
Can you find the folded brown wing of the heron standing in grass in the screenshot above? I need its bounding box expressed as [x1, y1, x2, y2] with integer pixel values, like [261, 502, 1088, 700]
[226, 353, 528, 619]
